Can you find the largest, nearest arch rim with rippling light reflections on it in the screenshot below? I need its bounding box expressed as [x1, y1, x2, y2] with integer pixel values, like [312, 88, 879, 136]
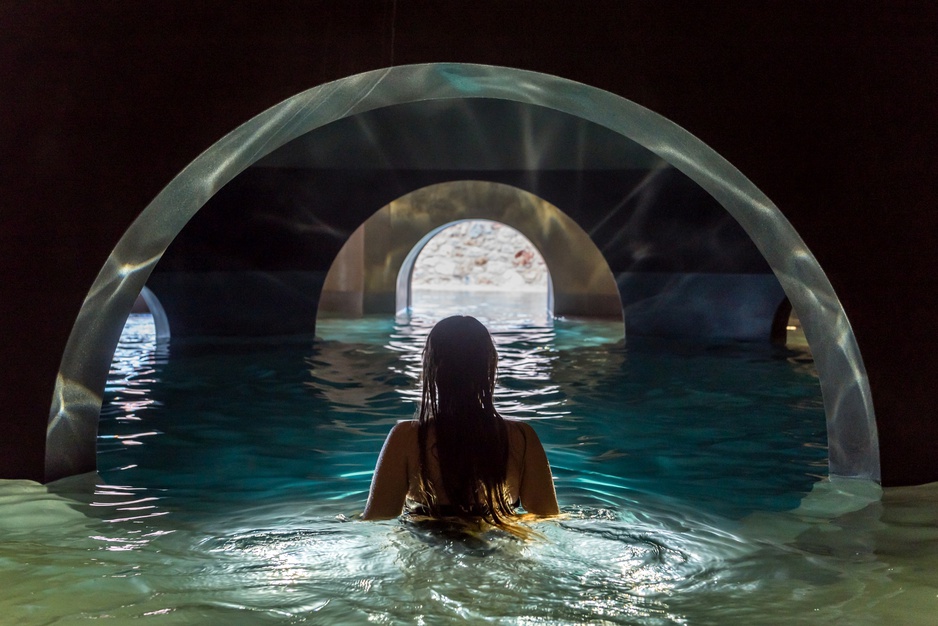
[46, 63, 880, 480]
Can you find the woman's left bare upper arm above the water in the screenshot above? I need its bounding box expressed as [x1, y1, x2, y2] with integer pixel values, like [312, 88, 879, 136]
[362, 422, 417, 520]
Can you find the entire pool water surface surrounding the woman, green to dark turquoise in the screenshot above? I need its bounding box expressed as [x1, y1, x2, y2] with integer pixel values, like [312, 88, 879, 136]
[0, 311, 938, 625]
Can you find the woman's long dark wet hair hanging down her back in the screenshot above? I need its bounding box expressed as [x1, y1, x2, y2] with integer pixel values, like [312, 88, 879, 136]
[417, 315, 516, 532]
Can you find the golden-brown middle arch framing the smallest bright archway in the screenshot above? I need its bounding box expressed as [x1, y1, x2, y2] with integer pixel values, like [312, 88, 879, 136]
[320, 180, 622, 318]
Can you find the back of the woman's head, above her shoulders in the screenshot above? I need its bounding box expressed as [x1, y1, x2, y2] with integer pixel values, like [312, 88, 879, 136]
[423, 315, 498, 416]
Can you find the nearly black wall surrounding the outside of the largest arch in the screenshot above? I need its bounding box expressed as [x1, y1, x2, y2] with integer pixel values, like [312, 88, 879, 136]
[0, 0, 938, 484]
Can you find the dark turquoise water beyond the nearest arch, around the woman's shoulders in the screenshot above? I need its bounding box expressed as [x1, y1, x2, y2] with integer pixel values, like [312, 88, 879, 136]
[98, 310, 827, 517]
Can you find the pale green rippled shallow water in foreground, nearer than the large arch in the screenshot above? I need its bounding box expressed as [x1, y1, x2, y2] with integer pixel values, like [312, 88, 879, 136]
[0, 476, 938, 624]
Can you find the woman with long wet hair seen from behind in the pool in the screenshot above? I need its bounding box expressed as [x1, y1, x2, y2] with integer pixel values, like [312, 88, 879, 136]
[362, 315, 559, 535]
